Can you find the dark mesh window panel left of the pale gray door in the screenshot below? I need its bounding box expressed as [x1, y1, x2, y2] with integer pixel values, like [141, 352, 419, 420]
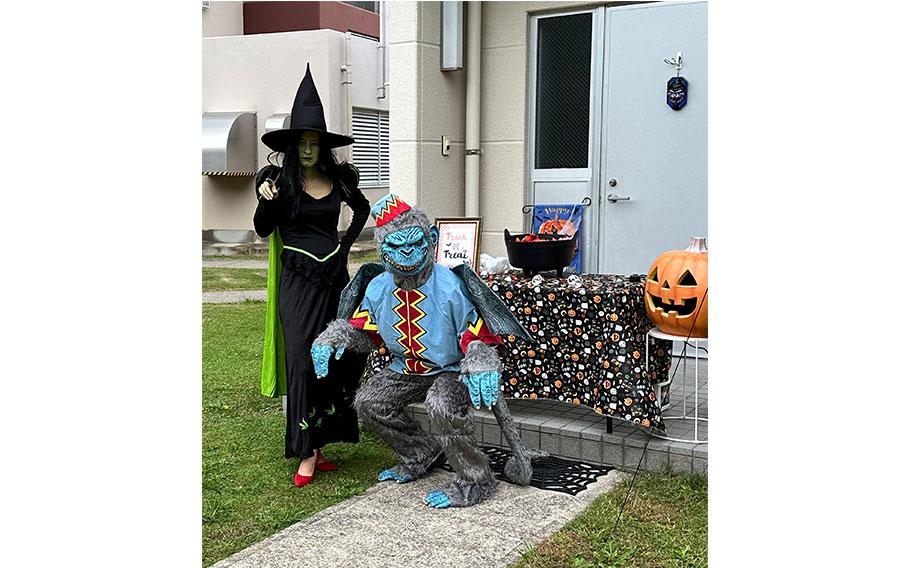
[534, 13, 592, 169]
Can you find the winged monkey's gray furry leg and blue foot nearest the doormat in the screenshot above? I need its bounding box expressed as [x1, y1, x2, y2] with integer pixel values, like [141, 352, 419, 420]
[426, 373, 499, 507]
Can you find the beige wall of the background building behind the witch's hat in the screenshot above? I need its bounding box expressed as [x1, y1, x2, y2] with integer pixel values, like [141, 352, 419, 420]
[202, 28, 388, 230]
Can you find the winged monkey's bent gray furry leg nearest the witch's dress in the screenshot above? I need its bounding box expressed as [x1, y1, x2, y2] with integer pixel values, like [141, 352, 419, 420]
[354, 369, 442, 483]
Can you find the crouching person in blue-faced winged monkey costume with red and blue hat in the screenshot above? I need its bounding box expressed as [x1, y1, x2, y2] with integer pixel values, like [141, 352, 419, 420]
[312, 194, 539, 509]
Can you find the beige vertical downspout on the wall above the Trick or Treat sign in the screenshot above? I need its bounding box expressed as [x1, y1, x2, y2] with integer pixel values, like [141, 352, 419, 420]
[464, 2, 482, 217]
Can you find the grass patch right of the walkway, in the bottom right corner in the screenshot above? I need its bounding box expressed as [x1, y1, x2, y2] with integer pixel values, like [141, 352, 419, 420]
[514, 472, 708, 568]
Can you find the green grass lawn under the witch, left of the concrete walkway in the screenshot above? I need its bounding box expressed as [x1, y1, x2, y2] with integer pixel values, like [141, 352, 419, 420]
[202, 302, 395, 566]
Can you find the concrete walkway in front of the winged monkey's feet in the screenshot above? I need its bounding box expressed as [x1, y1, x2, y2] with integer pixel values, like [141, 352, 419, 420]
[214, 470, 623, 568]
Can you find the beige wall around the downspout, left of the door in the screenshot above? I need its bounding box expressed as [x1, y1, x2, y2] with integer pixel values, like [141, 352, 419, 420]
[388, 1, 602, 256]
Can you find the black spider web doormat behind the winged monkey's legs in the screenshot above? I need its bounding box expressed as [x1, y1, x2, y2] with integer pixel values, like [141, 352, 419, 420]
[440, 446, 614, 495]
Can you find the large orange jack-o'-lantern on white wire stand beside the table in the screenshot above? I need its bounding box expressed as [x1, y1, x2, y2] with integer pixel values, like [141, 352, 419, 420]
[645, 237, 708, 337]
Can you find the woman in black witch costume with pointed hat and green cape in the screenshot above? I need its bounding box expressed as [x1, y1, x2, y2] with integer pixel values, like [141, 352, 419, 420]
[253, 65, 370, 487]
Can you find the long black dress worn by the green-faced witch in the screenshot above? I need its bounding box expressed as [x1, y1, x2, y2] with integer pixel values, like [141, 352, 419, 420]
[253, 167, 370, 459]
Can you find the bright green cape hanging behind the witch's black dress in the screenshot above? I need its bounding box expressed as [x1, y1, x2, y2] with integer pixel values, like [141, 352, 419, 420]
[262, 228, 288, 397]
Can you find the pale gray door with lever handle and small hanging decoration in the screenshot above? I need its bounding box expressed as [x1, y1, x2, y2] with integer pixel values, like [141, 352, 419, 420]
[594, 2, 710, 274]
